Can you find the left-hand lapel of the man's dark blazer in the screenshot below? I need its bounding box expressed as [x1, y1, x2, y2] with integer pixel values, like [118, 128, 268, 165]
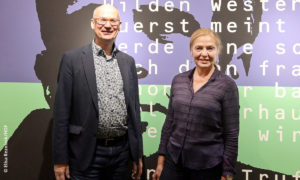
[81, 44, 99, 115]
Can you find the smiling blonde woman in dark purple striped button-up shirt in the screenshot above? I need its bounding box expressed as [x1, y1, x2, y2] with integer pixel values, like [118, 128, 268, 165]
[152, 28, 239, 180]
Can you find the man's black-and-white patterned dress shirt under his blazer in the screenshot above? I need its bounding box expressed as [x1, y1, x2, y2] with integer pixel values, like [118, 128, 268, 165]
[92, 41, 127, 138]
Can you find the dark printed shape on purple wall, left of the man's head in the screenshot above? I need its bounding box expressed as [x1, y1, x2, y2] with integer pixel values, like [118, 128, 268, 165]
[34, 0, 98, 109]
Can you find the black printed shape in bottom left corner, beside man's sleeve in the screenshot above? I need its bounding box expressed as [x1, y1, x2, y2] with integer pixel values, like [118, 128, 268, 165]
[0, 109, 54, 180]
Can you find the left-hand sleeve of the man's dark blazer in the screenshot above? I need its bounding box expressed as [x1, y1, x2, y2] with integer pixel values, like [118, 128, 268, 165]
[52, 54, 72, 164]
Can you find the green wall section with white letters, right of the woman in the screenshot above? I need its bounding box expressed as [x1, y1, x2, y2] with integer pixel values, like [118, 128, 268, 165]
[238, 87, 300, 175]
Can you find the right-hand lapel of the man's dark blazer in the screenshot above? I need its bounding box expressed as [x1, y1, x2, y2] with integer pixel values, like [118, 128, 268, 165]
[116, 50, 130, 107]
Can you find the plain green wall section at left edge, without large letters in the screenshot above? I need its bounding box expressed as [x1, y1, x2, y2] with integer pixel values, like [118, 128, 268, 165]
[0, 82, 49, 149]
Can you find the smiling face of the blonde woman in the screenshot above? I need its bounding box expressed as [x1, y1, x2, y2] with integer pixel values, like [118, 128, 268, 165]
[191, 35, 218, 68]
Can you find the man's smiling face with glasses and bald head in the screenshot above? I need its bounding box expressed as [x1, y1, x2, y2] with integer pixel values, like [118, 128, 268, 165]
[91, 6, 121, 42]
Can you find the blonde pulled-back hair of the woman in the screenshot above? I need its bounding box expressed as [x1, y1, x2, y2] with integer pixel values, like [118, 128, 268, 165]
[190, 28, 222, 54]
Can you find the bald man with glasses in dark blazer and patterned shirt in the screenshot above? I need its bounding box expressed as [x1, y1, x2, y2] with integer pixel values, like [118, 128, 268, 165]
[53, 5, 143, 180]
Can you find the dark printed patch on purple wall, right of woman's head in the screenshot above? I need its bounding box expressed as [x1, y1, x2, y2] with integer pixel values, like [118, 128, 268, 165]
[211, 0, 263, 79]
